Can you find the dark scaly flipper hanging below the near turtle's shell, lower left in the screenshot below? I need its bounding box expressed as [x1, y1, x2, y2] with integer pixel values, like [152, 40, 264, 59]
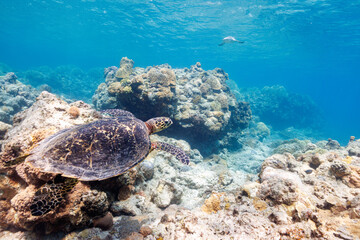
[30, 177, 78, 216]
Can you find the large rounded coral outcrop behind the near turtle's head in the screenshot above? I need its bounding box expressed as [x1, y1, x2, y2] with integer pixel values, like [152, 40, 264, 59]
[93, 58, 251, 140]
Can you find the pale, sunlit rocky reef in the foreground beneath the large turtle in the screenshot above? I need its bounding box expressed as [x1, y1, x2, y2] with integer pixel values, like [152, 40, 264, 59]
[0, 96, 360, 240]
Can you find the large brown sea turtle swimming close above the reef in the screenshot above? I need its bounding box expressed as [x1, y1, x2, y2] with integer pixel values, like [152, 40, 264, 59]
[5, 109, 190, 216]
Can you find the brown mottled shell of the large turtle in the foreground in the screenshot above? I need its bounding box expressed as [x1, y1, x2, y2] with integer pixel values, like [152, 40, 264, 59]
[26, 116, 151, 181]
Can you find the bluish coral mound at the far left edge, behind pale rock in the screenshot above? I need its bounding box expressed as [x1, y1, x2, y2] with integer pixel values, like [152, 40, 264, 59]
[0, 72, 39, 123]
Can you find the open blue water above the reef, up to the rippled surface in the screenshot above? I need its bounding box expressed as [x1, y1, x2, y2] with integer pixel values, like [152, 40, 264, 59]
[0, 0, 360, 143]
